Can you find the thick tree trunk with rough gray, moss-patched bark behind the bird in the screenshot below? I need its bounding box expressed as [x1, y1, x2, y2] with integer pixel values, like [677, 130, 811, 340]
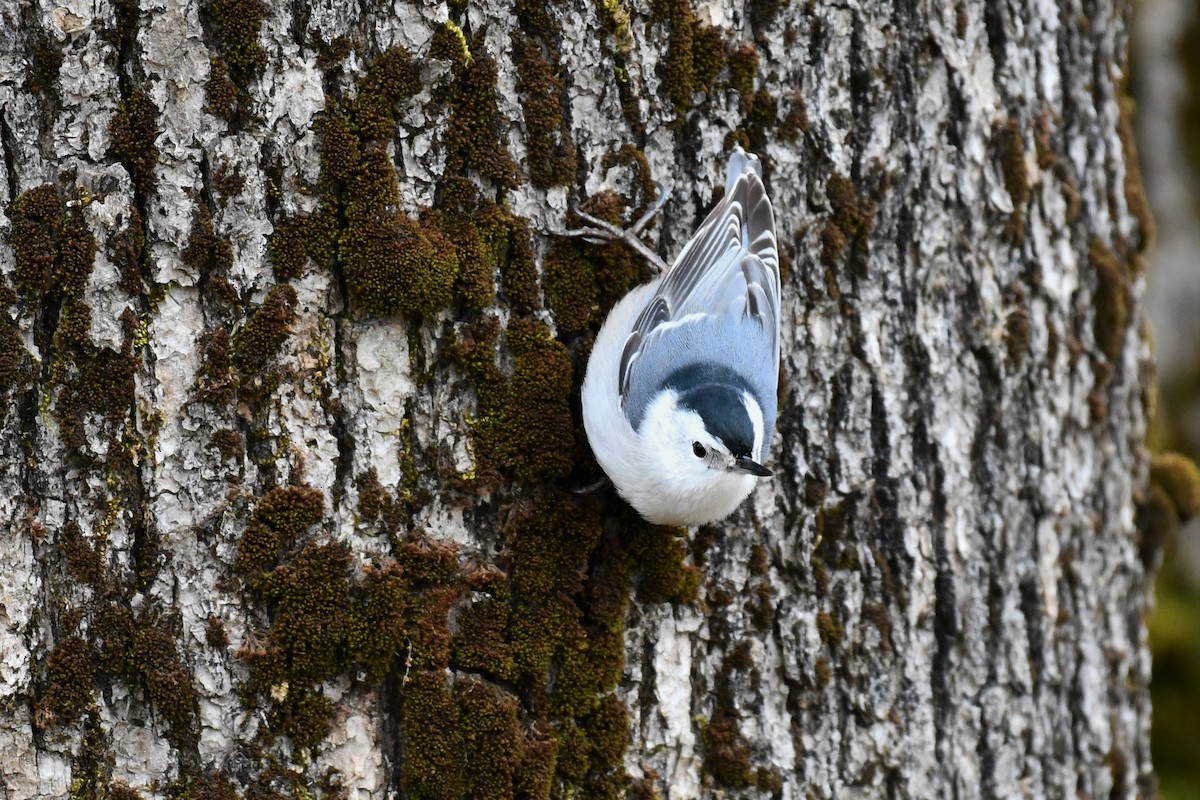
[0, 0, 1154, 799]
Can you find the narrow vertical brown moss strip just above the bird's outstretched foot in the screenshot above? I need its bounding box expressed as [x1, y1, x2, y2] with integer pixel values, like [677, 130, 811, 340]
[512, 32, 576, 188]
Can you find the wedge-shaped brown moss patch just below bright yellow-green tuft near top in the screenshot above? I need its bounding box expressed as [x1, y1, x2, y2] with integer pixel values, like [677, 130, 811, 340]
[443, 42, 518, 188]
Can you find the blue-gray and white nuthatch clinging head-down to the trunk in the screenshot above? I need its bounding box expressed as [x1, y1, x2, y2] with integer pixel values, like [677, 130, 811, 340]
[581, 146, 781, 527]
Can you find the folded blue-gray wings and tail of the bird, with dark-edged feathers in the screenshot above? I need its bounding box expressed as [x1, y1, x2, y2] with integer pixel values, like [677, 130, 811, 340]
[619, 146, 780, 407]
